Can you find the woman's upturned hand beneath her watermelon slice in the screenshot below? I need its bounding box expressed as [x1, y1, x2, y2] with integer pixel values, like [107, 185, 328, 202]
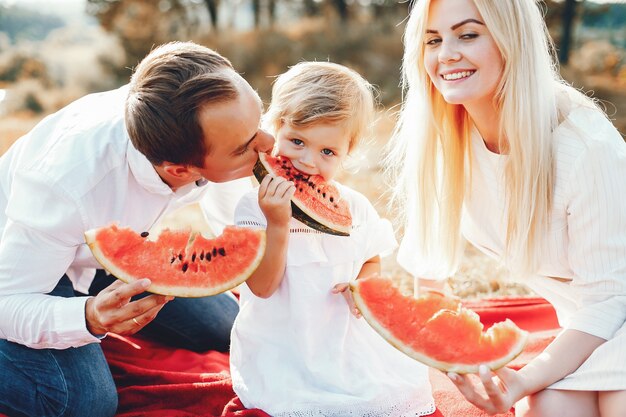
[448, 365, 525, 415]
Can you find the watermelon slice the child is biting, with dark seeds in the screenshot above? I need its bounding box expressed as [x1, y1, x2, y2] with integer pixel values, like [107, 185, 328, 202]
[254, 153, 352, 236]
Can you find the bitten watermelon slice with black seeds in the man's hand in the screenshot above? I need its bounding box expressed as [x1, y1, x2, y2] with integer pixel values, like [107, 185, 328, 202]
[85, 225, 265, 297]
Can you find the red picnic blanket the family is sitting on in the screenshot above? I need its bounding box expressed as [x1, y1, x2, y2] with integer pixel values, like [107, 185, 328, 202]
[95, 298, 558, 417]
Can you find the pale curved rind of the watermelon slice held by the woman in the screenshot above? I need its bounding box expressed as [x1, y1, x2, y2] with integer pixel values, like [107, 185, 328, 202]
[350, 280, 528, 374]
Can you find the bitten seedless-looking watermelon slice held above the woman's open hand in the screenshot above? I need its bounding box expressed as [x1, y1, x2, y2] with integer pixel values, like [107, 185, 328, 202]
[350, 277, 528, 374]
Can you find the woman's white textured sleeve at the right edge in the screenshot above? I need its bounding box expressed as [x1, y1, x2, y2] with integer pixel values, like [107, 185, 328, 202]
[567, 135, 626, 339]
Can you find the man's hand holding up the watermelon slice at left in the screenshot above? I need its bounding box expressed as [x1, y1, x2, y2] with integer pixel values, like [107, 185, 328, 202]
[85, 278, 174, 335]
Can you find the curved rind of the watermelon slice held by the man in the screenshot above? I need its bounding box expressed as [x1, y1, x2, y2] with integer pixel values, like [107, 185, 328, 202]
[85, 228, 266, 298]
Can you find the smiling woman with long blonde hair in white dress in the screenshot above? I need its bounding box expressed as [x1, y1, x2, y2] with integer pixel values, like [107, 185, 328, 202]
[389, 0, 626, 417]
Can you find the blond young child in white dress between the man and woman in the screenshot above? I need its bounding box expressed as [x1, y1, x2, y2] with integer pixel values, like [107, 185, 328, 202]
[231, 62, 435, 417]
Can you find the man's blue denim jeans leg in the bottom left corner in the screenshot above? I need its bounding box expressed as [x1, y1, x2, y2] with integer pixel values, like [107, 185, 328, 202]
[0, 277, 117, 417]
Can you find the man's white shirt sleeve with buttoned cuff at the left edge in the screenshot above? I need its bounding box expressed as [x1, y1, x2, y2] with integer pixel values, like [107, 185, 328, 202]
[0, 172, 99, 349]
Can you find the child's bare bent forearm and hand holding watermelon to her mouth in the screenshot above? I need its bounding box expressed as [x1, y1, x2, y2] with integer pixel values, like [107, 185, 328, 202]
[246, 175, 295, 298]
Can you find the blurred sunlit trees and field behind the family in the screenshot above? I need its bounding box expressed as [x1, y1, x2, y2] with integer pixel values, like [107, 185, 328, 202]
[0, 0, 626, 296]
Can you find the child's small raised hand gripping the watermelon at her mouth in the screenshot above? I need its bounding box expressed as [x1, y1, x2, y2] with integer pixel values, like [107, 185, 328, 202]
[259, 175, 296, 225]
